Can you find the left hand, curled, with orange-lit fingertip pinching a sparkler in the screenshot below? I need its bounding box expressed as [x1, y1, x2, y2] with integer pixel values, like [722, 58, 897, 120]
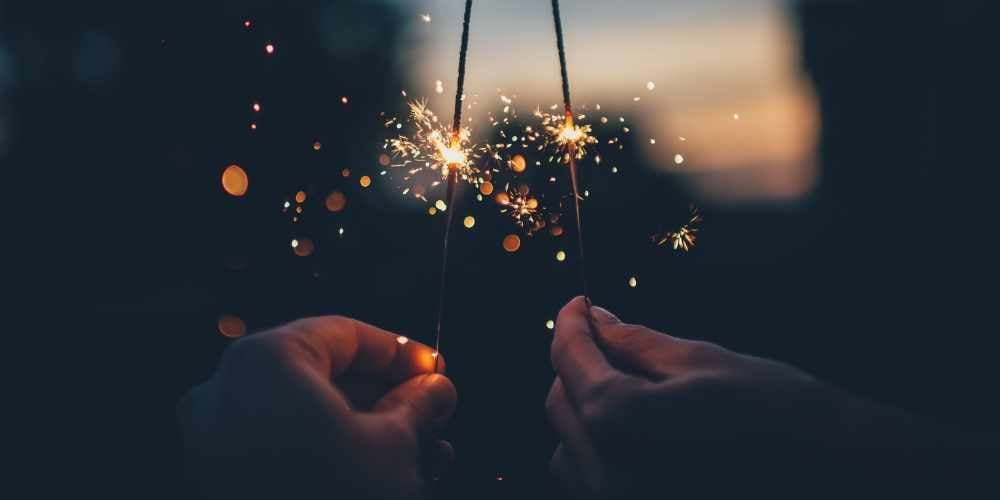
[178, 316, 456, 499]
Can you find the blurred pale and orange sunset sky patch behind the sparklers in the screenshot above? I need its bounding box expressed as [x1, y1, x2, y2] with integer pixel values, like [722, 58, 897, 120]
[386, 0, 819, 203]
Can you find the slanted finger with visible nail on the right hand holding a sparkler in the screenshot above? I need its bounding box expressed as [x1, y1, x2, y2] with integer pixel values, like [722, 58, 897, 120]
[590, 306, 689, 379]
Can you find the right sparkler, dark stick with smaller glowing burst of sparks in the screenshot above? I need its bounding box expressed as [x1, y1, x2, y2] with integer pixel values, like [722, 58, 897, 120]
[543, 0, 597, 305]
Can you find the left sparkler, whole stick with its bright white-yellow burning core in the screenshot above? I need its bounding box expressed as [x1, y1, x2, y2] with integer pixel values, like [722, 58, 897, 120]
[432, 0, 472, 373]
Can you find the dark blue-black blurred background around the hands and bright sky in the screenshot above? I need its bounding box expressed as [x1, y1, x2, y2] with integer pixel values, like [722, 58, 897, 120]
[0, 1, 1000, 498]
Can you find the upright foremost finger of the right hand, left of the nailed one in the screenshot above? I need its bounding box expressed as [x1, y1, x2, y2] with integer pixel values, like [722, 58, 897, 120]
[552, 297, 615, 404]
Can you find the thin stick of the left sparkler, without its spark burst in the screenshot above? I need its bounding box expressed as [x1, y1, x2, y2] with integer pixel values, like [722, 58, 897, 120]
[434, 0, 472, 373]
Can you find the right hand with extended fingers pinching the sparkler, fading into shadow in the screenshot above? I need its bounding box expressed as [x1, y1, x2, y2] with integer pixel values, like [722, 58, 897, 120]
[546, 297, 928, 497]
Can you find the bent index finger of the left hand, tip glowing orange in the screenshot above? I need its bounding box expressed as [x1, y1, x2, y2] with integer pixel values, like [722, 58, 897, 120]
[275, 316, 444, 383]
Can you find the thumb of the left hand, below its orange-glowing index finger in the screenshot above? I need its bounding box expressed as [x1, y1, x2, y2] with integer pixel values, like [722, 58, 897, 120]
[375, 373, 458, 431]
